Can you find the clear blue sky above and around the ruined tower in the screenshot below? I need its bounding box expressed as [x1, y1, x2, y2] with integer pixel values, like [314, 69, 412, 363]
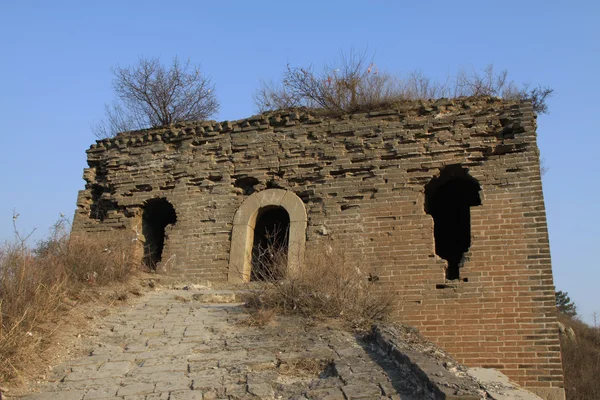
[0, 0, 600, 321]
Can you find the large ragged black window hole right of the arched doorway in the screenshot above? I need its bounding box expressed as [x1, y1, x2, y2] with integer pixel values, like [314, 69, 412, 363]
[425, 165, 481, 280]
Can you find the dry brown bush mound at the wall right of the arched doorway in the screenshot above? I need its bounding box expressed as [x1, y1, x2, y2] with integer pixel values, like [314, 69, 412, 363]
[247, 244, 393, 330]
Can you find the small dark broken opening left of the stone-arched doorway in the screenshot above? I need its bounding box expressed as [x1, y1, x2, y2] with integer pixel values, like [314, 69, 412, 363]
[142, 199, 177, 269]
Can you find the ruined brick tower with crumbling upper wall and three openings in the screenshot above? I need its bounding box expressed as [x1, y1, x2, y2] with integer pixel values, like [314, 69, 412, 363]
[73, 98, 563, 398]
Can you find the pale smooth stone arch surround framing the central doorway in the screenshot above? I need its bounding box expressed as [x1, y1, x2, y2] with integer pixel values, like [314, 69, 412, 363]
[228, 189, 307, 282]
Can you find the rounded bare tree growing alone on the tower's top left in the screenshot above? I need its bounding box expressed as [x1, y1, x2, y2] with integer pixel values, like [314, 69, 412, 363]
[92, 57, 219, 138]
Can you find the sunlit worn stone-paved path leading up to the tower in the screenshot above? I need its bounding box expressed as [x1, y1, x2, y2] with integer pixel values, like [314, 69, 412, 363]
[15, 289, 423, 400]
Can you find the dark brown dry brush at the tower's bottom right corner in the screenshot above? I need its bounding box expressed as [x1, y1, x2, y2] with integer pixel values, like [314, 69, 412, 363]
[559, 314, 600, 400]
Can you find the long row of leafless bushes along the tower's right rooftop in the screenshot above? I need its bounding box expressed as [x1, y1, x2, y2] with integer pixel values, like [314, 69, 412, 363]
[254, 52, 552, 114]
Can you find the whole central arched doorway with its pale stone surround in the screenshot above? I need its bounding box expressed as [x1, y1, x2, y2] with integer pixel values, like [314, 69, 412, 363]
[228, 189, 307, 282]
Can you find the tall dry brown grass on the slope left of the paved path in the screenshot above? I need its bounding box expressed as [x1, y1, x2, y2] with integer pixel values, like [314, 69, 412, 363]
[0, 217, 135, 382]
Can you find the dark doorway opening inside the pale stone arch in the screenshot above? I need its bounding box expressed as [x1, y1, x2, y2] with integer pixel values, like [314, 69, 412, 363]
[250, 207, 290, 281]
